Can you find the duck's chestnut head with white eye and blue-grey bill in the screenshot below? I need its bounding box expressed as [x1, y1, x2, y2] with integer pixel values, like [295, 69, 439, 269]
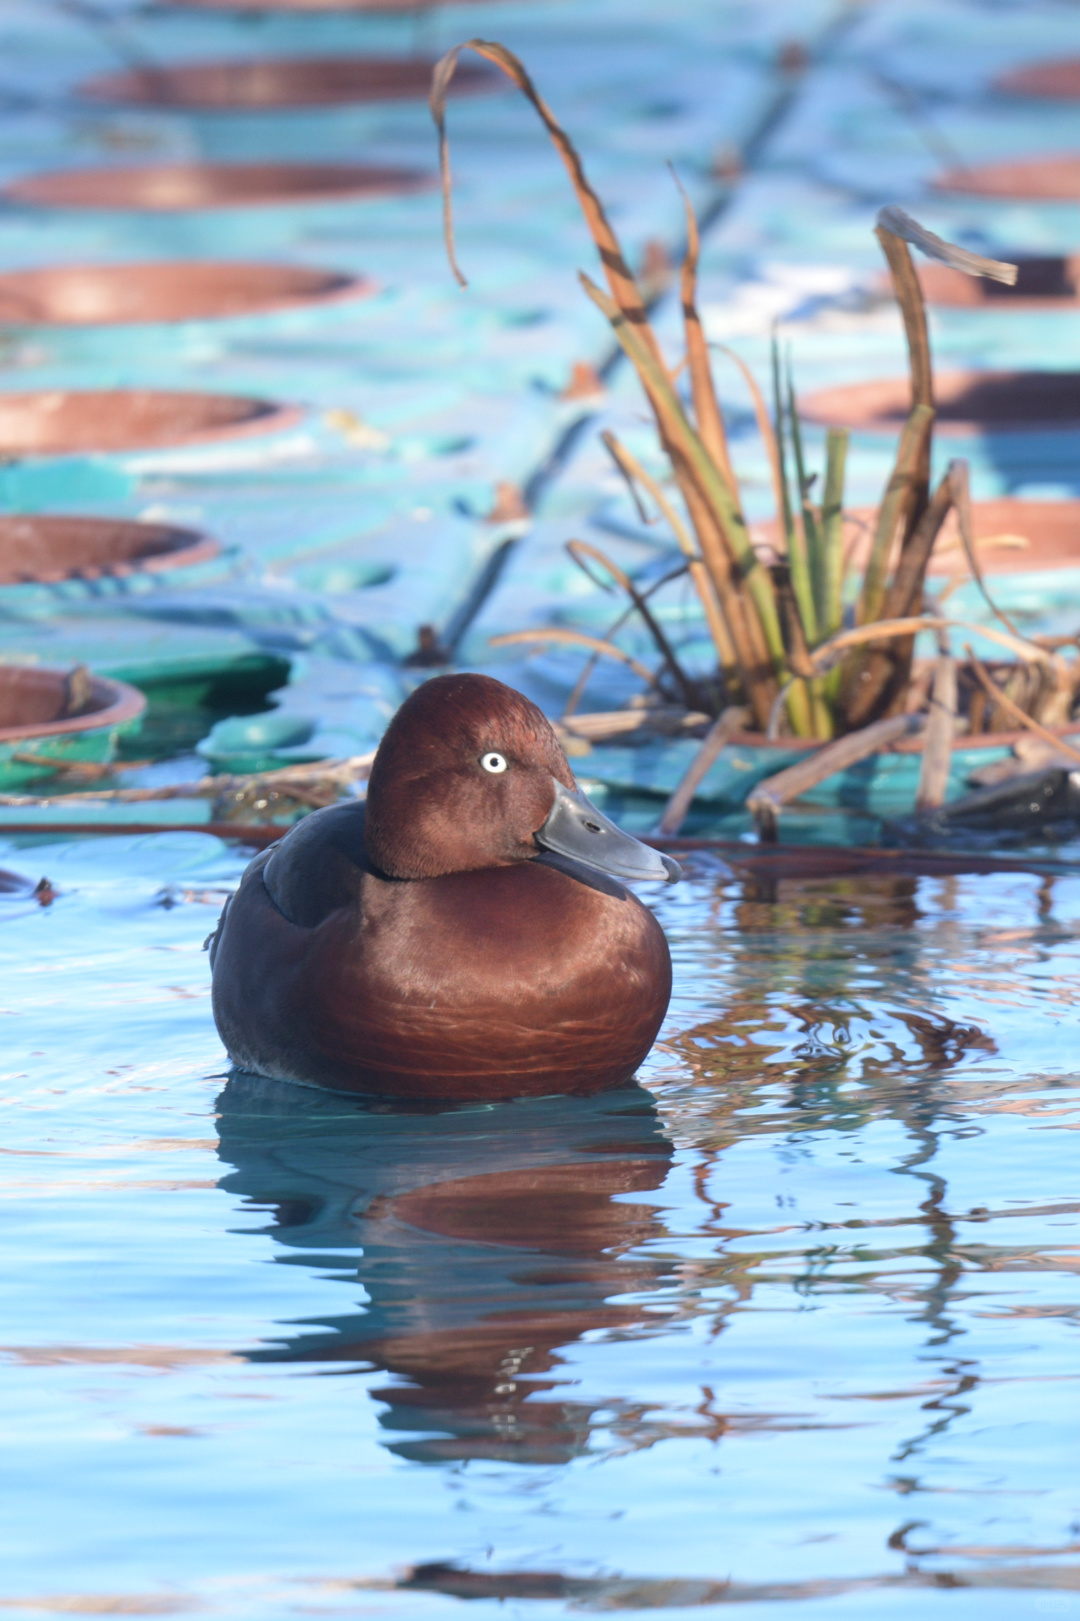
[365, 674, 681, 882]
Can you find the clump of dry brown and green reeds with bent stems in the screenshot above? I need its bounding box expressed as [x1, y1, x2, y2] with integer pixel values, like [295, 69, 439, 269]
[431, 39, 1080, 784]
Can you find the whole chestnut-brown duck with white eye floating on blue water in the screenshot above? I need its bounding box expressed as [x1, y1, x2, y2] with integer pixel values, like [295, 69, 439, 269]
[209, 671, 681, 1104]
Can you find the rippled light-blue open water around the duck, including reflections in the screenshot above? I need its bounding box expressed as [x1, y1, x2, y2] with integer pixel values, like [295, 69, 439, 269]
[0, 835, 1080, 1621]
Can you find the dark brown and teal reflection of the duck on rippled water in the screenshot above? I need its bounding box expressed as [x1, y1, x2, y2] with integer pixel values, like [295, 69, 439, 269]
[219, 1073, 671, 1464]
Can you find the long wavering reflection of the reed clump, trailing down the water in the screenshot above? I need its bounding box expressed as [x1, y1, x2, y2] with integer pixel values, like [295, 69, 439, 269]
[655, 872, 1024, 1517]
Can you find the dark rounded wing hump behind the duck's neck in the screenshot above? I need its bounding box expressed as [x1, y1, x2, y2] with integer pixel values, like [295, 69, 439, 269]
[263, 801, 371, 929]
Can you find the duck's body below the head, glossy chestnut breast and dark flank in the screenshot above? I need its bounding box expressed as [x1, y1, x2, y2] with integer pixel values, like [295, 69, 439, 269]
[207, 861, 671, 1099]
